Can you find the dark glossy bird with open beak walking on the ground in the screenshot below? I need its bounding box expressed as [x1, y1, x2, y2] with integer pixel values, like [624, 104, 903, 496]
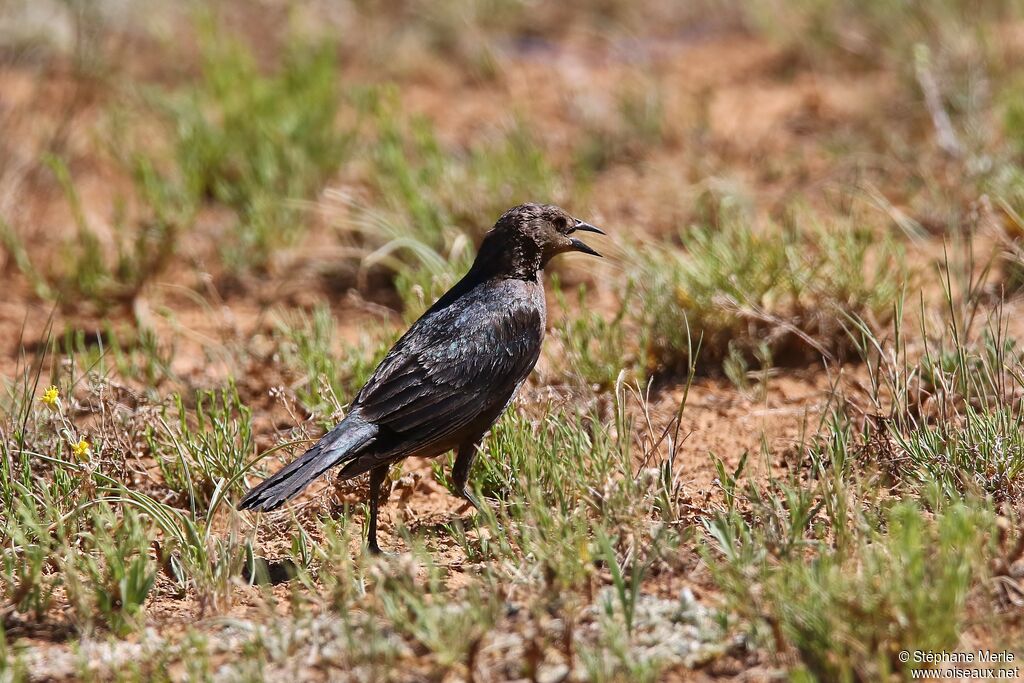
[238, 204, 605, 554]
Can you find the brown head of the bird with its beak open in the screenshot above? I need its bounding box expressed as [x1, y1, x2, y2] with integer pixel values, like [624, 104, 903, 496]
[477, 204, 604, 276]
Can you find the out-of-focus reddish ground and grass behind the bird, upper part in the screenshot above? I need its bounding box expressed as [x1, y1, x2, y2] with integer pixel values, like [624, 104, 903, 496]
[0, 0, 1024, 385]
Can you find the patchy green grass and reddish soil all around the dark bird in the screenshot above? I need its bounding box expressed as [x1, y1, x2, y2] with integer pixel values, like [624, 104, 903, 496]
[0, 0, 1024, 681]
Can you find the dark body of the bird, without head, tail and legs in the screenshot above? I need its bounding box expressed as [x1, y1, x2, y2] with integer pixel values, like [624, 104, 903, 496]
[342, 272, 546, 476]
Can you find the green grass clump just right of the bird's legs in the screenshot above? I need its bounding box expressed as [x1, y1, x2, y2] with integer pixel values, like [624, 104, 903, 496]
[428, 395, 678, 573]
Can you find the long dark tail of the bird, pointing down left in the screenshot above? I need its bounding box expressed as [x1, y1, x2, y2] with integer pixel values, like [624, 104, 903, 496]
[239, 415, 378, 510]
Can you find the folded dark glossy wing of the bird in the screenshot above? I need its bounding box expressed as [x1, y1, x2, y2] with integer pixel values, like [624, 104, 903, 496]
[353, 300, 543, 443]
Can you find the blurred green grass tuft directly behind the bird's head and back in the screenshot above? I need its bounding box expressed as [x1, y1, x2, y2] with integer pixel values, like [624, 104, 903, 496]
[340, 99, 560, 321]
